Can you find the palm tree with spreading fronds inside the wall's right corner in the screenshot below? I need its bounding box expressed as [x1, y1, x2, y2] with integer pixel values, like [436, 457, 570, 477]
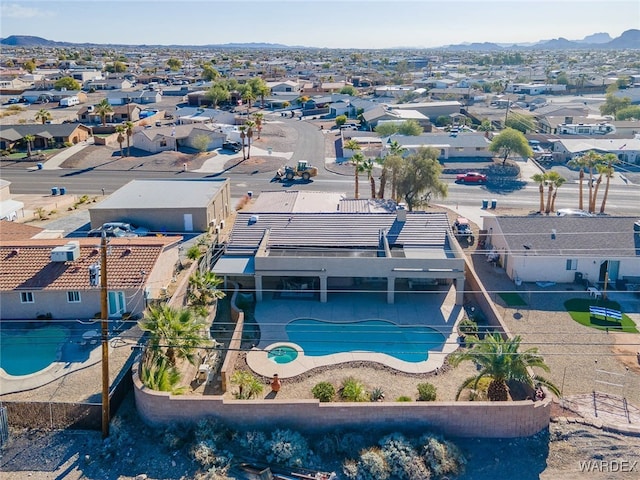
[449, 333, 560, 402]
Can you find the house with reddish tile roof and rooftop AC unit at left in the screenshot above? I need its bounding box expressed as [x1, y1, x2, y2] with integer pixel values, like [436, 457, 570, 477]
[0, 235, 182, 320]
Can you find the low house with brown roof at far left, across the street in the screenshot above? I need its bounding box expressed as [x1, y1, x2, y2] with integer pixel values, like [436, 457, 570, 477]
[0, 123, 92, 150]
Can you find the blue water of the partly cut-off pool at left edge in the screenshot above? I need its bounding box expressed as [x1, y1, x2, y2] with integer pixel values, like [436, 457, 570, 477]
[0, 326, 68, 376]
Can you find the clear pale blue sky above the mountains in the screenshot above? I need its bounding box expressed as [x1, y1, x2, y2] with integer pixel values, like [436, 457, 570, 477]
[0, 0, 640, 48]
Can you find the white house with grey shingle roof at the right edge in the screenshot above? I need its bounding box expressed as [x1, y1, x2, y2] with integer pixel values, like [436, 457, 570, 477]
[482, 215, 640, 285]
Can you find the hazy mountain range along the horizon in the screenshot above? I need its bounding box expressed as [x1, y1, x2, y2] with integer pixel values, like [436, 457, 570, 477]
[0, 29, 640, 51]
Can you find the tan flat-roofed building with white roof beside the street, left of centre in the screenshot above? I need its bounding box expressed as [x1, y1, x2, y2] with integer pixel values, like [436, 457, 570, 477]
[89, 178, 232, 234]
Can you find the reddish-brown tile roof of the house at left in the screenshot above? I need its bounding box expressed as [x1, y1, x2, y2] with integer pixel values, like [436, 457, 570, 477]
[0, 237, 182, 291]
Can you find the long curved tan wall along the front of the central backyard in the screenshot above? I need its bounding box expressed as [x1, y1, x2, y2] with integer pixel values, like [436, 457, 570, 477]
[133, 367, 551, 438]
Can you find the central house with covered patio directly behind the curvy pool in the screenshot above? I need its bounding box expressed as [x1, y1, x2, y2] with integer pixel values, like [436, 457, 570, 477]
[213, 198, 465, 305]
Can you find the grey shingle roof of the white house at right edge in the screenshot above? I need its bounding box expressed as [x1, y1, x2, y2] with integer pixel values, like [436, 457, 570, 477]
[495, 216, 640, 257]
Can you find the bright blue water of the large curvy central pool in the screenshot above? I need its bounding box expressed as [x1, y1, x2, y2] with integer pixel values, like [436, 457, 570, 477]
[286, 318, 445, 362]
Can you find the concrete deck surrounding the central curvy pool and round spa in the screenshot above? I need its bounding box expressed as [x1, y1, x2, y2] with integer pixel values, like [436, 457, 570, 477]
[247, 287, 464, 378]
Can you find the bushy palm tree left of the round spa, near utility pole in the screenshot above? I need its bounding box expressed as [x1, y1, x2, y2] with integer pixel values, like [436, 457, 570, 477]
[138, 305, 210, 366]
